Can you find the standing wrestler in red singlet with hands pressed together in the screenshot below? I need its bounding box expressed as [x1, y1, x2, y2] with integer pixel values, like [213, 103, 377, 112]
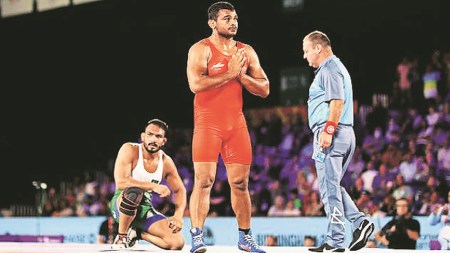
[187, 2, 269, 253]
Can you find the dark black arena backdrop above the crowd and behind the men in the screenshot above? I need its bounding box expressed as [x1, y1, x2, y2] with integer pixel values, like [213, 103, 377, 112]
[0, 0, 450, 218]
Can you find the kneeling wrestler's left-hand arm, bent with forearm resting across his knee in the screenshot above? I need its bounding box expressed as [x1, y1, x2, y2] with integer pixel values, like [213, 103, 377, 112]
[114, 143, 170, 197]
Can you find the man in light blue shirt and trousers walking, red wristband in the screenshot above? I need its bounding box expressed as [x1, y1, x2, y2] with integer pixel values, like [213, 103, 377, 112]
[303, 31, 374, 252]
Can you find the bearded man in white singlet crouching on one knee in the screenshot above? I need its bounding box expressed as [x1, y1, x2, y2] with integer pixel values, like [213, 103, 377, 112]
[110, 119, 187, 250]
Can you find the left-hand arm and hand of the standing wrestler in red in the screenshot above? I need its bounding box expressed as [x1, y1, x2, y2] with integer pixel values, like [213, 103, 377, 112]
[186, 42, 245, 93]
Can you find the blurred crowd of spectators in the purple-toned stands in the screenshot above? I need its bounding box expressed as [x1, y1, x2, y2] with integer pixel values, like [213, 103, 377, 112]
[13, 48, 450, 220]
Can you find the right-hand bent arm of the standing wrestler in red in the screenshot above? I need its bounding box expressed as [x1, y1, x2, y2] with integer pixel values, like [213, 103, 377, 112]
[238, 45, 270, 98]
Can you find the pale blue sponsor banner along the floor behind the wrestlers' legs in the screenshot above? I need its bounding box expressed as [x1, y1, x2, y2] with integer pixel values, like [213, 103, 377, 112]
[0, 216, 441, 250]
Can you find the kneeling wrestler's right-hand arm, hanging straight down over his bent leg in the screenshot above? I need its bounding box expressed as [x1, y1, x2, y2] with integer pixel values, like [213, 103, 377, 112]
[163, 155, 187, 220]
